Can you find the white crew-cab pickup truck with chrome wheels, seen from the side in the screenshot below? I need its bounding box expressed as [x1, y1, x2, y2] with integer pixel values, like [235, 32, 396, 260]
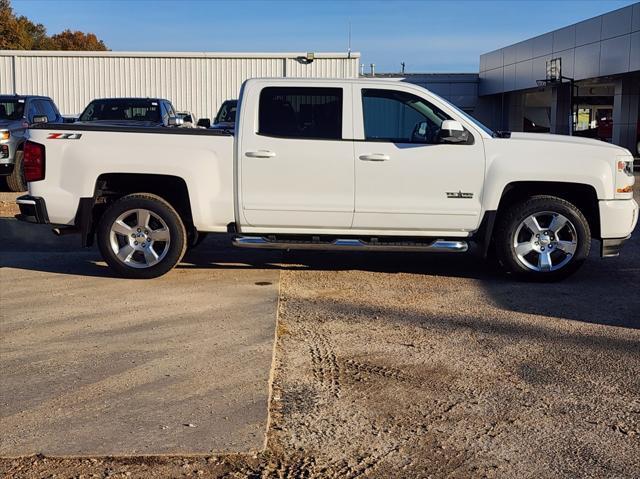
[17, 79, 638, 280]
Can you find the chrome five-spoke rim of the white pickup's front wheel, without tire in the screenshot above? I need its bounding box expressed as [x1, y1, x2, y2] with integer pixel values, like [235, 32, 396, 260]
[513, 211, 578, 272]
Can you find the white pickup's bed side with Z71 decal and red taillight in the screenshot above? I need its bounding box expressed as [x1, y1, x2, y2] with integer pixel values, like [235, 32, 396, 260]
[29, 123, 234, 231]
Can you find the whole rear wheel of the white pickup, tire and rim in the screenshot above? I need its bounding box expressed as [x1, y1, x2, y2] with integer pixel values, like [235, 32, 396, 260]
[97, 193, 187, 279]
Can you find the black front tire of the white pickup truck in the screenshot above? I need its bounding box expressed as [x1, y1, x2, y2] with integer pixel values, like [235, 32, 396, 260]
[494, 196, 591, 281]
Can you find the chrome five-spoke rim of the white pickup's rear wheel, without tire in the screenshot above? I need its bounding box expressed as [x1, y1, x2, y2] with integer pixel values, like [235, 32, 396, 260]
[109, 209, 170, 268]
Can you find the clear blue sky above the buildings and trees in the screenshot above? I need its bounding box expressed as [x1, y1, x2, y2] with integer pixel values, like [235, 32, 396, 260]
[12, 0, 634, 72]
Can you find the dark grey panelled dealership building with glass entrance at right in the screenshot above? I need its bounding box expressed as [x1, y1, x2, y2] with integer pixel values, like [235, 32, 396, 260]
[475, 2, 640, 154]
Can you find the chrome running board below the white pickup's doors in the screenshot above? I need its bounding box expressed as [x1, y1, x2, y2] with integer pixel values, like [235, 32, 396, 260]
[232, 236, 469, 253]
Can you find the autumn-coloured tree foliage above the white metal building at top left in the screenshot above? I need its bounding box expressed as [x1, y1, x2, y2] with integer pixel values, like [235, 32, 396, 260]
[0, 0, 108, 51]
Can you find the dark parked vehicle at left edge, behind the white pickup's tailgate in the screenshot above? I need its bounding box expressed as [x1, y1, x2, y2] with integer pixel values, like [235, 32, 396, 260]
[0, 95, 63, 191]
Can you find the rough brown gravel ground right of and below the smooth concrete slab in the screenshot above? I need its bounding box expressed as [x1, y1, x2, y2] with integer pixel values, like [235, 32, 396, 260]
[0, 181, 640, 478]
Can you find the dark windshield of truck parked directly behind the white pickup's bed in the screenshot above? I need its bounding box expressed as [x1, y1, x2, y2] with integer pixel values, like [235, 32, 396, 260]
[80, 99, 161, 122]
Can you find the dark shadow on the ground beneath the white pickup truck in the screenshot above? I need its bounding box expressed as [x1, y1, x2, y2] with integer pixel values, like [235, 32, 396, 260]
[0, 218, 640, 329]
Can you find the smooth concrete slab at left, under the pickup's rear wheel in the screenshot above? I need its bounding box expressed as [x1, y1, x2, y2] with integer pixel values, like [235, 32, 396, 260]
[0, 218, 279, 456]
